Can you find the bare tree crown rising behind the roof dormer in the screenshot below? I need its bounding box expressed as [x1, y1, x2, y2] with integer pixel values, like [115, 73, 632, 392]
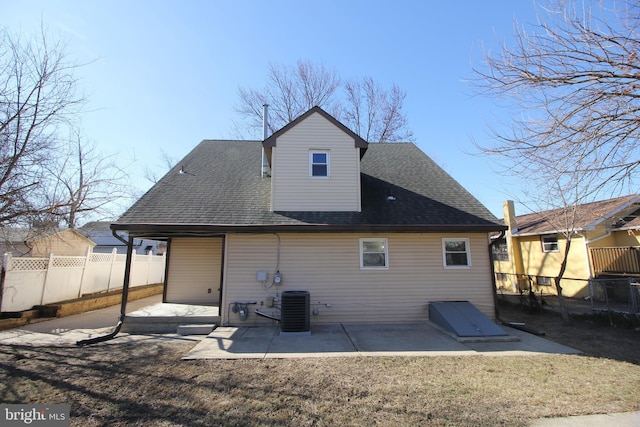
[236, 61, 412, 142]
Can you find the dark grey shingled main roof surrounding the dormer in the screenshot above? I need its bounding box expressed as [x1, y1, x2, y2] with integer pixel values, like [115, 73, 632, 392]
[112, 140, 505, 237]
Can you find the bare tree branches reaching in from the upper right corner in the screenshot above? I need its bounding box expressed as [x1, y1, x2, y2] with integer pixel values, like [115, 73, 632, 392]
[475, 0, 640, 195]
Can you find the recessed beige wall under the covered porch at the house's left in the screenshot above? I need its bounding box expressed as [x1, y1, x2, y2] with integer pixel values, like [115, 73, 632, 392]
[165, 238, 223, 305]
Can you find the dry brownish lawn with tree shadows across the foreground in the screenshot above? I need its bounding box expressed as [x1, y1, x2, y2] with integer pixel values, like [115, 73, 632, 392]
[0, 302, 640, 426]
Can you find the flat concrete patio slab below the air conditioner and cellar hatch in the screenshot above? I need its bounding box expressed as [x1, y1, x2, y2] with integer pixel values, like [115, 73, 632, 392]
[183, 322, 580, 360]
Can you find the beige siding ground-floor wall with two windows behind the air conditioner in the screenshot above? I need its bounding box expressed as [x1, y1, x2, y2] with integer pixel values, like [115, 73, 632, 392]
[220, 233, 494, 325]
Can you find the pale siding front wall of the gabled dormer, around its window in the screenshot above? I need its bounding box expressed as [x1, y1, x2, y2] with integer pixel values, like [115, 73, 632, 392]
[271, 114, 360, 212]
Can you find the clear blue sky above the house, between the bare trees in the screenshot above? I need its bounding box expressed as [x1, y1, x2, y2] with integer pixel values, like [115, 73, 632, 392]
[0, 0, 535, 218]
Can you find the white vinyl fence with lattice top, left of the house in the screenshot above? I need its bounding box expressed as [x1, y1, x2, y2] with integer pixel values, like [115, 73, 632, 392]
[0, 249, 166, 312]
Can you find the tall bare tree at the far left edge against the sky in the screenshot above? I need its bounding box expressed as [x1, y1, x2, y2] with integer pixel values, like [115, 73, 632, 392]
[0, 25, 83, 225]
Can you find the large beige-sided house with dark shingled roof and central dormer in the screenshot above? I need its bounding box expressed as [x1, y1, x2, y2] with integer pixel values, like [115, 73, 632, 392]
[112, 107, 505, 325]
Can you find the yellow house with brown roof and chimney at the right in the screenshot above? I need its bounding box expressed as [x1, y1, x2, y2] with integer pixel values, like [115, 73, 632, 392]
[493, 194, 640, 297]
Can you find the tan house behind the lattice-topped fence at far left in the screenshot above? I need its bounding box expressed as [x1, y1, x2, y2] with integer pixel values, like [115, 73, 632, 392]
[0, 228, 96, 258]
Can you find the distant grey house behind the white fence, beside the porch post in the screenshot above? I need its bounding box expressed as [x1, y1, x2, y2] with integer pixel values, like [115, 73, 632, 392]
[78, 221, 166, 255]
